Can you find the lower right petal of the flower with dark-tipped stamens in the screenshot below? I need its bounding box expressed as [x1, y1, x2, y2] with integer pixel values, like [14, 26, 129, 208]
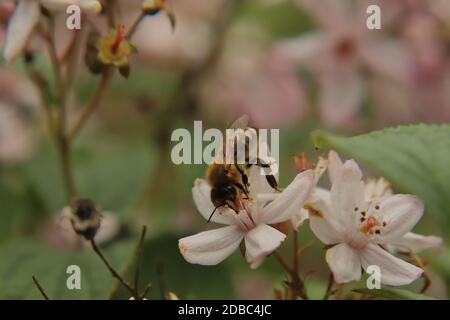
[361, 243, 423, 286]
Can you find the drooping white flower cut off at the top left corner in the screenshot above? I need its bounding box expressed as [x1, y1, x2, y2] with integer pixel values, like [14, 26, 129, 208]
[3, 0, 102, 62]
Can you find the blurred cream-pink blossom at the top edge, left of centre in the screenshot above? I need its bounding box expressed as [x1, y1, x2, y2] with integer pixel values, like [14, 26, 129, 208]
[119, 0, 225, 66]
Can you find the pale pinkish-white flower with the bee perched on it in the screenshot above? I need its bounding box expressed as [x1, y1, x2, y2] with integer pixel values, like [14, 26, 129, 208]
[178, 167, 314, 268]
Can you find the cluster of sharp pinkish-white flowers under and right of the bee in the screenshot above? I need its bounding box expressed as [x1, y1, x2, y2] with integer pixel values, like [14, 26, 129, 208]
[179, 151, 442, 286]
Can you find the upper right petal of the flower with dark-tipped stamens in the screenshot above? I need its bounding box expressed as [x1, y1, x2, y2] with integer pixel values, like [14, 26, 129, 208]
[378, 194, 424, 243]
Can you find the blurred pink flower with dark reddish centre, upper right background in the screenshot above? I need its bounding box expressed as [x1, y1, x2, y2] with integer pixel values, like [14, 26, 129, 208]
[274, 0, 412, 127]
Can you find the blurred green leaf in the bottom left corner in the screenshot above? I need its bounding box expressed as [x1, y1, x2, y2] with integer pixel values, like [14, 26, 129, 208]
[0, 239, 132, 300]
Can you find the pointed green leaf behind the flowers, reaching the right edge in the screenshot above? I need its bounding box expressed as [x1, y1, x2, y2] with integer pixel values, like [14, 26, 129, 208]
[312, 124, 450, 232]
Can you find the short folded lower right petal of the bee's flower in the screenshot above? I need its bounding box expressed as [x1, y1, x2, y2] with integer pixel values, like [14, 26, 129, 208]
[245, 224, 286, 269]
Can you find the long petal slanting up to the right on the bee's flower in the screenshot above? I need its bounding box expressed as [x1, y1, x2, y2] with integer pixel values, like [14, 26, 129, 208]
[255, 170, 314, 224]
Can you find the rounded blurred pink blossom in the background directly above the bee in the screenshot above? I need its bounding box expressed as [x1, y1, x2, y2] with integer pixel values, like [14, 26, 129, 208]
[203, 27, 307, 128]
